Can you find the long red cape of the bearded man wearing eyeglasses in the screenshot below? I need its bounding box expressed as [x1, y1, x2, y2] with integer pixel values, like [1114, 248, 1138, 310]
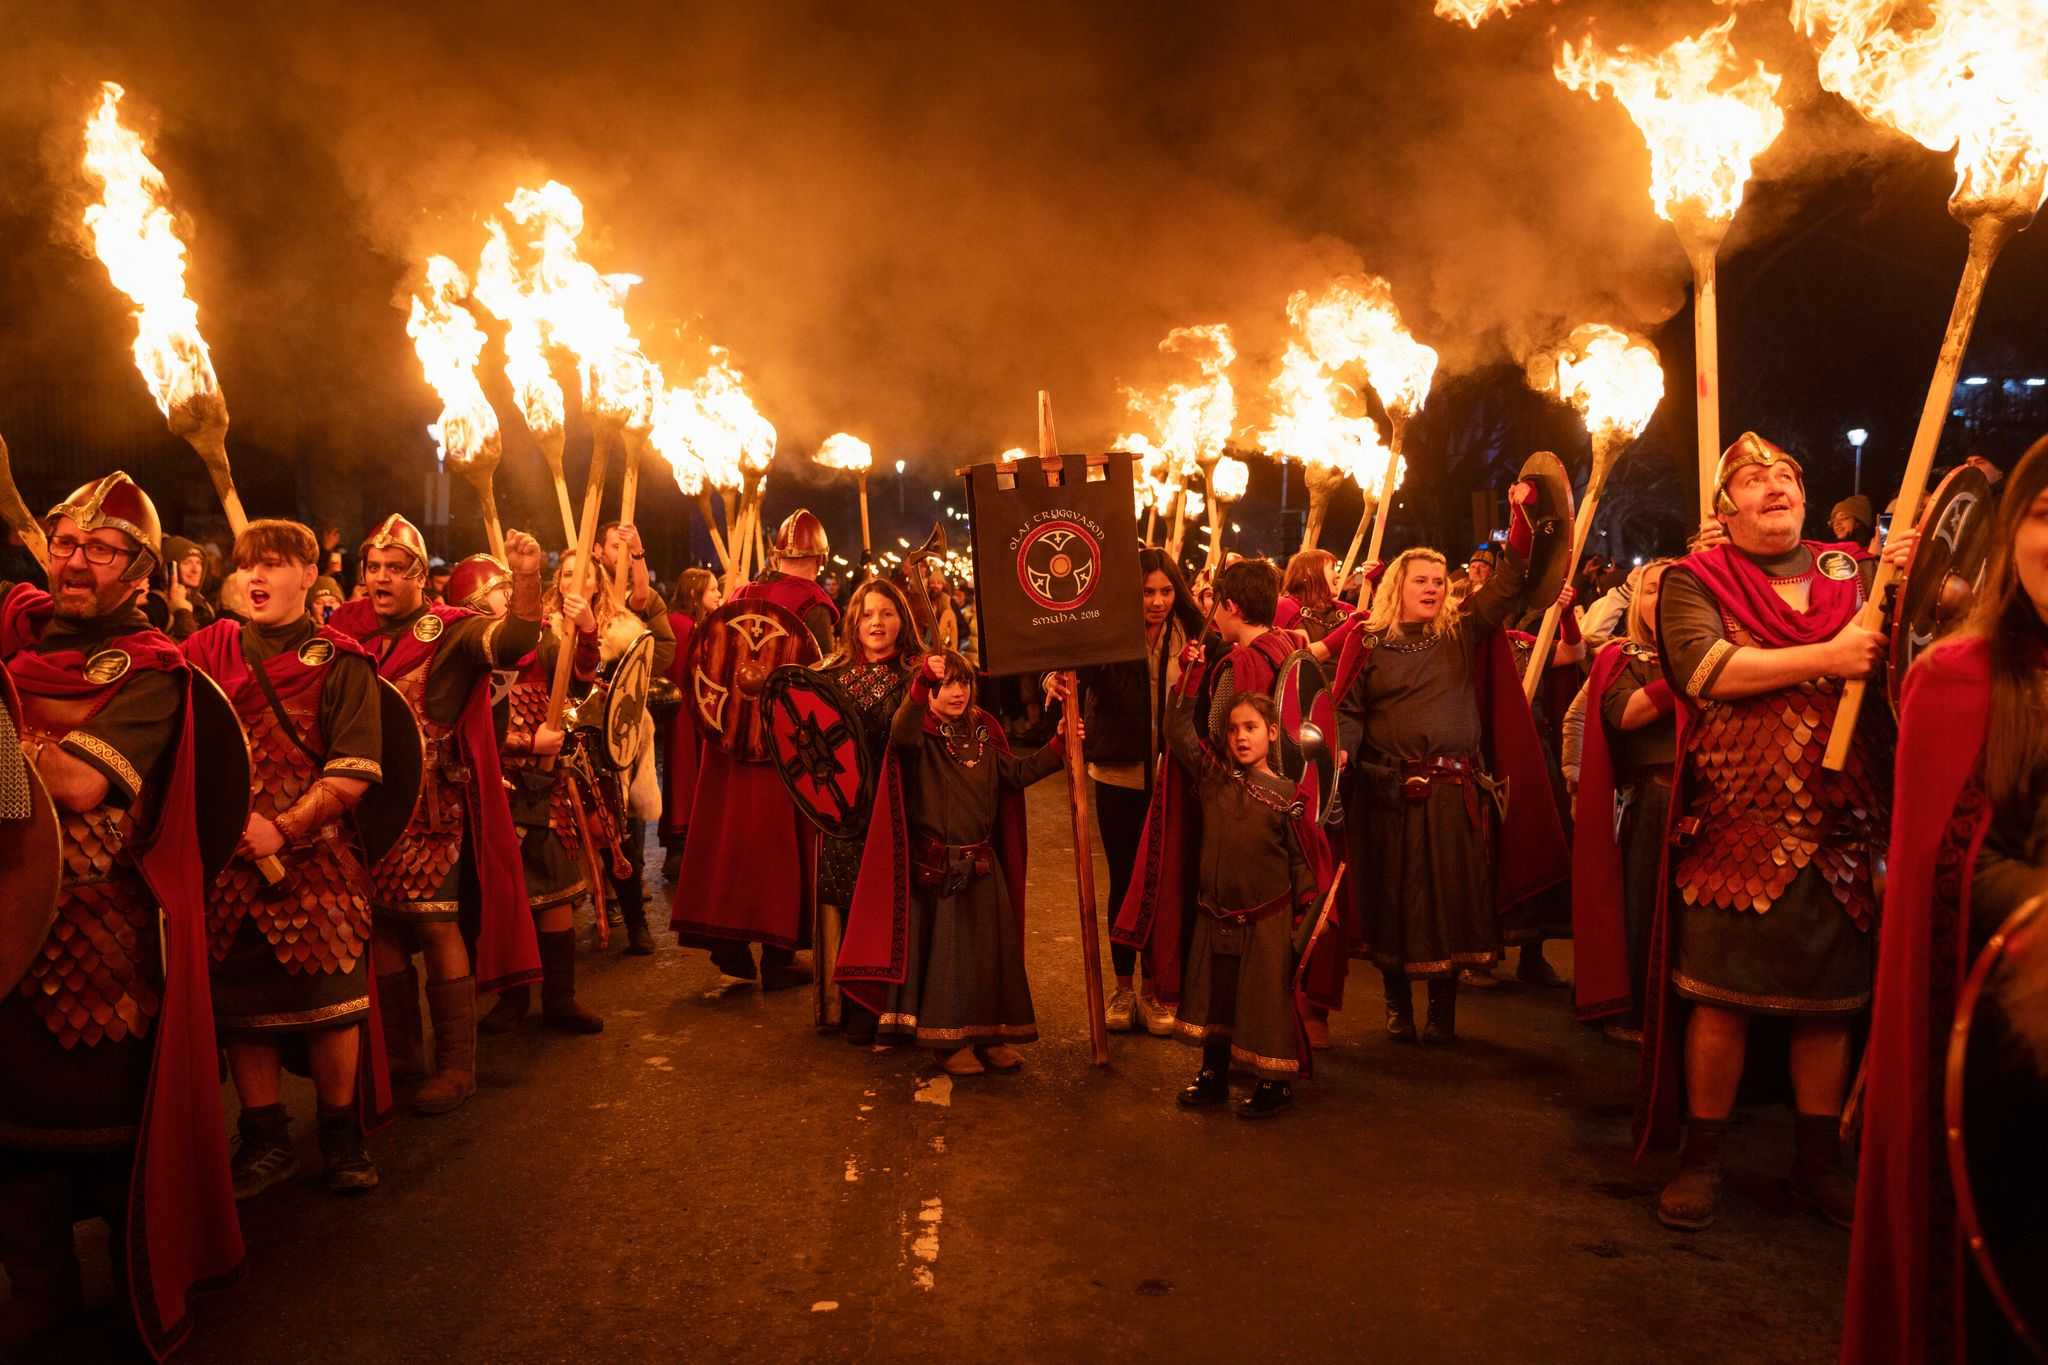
[0, 587, 244, 1359]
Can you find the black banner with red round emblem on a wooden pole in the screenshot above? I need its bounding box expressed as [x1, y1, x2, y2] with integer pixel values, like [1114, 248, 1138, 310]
[967, 452, 1145, 675]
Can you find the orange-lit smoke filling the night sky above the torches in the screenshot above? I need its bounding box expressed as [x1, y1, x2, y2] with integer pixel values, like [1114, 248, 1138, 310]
[0, 0, 2015, 532]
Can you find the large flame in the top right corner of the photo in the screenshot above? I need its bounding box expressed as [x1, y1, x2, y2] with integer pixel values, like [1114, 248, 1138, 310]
[1792, 0, 2048, 219]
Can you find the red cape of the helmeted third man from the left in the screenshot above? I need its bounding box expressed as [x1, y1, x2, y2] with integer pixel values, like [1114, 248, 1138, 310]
[328, 598, 541, 990]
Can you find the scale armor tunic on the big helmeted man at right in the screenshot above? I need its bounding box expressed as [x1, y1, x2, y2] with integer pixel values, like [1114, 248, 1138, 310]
[1659, 551, 1892, 1015]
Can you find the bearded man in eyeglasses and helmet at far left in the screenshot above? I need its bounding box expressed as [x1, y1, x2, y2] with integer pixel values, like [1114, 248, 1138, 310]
[0, 473, 242, 1355]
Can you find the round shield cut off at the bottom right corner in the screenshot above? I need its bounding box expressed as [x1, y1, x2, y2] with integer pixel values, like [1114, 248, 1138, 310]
[1944, 896, 2048, 1357]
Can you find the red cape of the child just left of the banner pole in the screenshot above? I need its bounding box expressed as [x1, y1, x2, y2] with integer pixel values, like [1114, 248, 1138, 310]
[831, 703, 1032, 1015]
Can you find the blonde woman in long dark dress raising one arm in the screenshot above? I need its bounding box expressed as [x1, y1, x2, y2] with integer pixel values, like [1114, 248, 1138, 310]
[1335, 483, 1569, 1042]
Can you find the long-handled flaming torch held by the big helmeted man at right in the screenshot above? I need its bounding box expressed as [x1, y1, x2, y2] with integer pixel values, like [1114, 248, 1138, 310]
[1792, 0, 2048, 772]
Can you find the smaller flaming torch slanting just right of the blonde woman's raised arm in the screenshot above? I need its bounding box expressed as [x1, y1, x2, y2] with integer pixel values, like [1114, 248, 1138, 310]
[1522, 323, 1663, 698]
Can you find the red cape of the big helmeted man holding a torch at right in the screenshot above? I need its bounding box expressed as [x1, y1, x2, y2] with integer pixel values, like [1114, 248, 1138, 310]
[1636, 540, 1868, 1158]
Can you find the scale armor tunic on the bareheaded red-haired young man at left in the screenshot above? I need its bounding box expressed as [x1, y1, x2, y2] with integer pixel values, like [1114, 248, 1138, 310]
[207, 620, 383, 1033]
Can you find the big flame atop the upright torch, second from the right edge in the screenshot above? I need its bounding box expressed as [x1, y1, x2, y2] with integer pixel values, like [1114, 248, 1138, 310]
[1556, 14, 1786, 223]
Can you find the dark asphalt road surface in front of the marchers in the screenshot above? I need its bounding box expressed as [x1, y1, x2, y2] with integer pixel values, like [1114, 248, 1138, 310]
[19, 778, 1847, 1365]
